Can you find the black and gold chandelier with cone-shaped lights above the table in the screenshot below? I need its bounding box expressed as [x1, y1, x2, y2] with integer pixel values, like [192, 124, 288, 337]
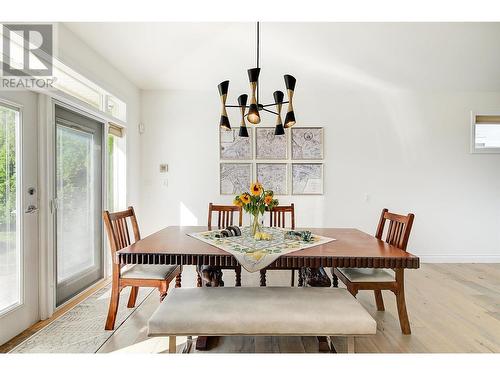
[218, 22, 296, 137]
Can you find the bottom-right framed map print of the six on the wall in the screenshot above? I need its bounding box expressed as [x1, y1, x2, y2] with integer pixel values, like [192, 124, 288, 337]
[292, 163, 323, 195]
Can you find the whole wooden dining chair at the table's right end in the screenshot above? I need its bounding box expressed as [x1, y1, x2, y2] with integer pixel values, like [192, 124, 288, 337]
[332, 208, 415, 335]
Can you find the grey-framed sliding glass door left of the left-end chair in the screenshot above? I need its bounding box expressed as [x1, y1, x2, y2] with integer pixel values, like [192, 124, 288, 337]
[55, 106, 104, 305]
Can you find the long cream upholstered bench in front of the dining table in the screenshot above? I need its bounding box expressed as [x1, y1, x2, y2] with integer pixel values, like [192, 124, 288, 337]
[148, 287, 377, 353]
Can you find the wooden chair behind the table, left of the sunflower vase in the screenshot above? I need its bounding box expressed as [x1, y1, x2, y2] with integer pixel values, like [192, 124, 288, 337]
[196, 203, 243, 287]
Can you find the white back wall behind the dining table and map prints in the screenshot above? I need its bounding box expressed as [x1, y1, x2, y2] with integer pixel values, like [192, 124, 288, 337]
[141, 86, 500, 261]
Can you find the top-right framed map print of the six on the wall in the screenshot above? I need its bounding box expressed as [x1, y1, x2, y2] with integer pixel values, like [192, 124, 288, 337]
[291, 128, 323, 160]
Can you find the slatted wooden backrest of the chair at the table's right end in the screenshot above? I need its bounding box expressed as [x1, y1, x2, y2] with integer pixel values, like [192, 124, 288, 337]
[375, 208, 415, 251]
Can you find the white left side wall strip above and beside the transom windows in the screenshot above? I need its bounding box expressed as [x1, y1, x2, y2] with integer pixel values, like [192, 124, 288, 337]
[57, 23, 141, 212]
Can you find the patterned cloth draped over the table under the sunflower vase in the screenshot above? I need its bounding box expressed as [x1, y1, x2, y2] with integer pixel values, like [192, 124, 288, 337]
[188, 227, 335, 272]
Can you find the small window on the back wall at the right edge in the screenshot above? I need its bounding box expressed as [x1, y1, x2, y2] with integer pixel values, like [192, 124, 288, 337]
[471, 115, 500, 153]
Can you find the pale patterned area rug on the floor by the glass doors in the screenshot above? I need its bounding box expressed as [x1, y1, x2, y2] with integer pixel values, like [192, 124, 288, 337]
[10, 285, 154, 353]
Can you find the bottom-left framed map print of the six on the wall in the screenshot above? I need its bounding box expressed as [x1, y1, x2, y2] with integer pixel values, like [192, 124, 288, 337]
[220, 163, 252, 195]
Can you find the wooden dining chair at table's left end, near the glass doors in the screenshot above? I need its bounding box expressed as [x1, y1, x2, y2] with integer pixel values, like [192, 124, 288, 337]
[102, 207, 182, 330]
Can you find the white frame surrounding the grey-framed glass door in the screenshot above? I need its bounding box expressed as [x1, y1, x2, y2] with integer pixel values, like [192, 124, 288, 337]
[39, 95, 110, 320]
